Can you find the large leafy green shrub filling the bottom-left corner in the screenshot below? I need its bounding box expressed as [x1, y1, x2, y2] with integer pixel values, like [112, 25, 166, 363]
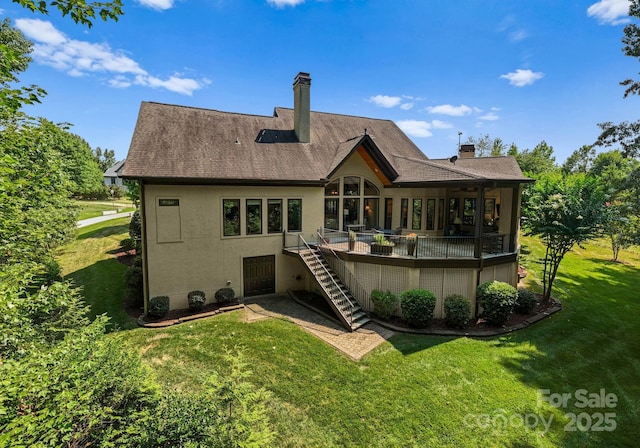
[0, 316, 157, 447]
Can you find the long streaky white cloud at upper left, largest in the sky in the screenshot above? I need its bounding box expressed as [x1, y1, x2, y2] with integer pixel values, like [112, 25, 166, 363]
[16, 19, 208, 95]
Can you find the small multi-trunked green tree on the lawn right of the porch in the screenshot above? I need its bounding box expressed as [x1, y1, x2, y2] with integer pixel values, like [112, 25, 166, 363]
[523, 172, 606, 301]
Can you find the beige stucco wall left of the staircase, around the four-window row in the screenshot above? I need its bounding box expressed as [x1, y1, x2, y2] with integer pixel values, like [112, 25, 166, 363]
[144, 185, 324, 309]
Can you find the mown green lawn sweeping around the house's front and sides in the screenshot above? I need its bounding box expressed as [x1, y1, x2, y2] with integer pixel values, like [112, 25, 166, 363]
[57, 222, 640, 447]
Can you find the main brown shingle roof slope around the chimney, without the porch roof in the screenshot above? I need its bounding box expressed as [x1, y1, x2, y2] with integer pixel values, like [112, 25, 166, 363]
[124, 102, 426, 181]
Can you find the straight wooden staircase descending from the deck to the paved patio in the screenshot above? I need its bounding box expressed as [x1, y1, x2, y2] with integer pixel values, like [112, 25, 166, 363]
[298, 246, 369, 331]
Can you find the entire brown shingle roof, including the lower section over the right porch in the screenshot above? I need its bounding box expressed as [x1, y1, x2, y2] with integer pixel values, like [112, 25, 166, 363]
[123, 102, 527, 183]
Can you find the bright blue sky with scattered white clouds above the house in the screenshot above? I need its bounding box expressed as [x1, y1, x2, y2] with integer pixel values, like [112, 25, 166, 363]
[0, 0, 638, 162]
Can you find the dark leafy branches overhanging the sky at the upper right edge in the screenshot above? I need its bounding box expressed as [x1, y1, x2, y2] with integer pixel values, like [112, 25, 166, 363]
[595, 0, 640, 157]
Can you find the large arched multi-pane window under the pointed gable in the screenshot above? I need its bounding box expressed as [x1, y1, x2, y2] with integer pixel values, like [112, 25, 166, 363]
[324, 176, 380, 230]
